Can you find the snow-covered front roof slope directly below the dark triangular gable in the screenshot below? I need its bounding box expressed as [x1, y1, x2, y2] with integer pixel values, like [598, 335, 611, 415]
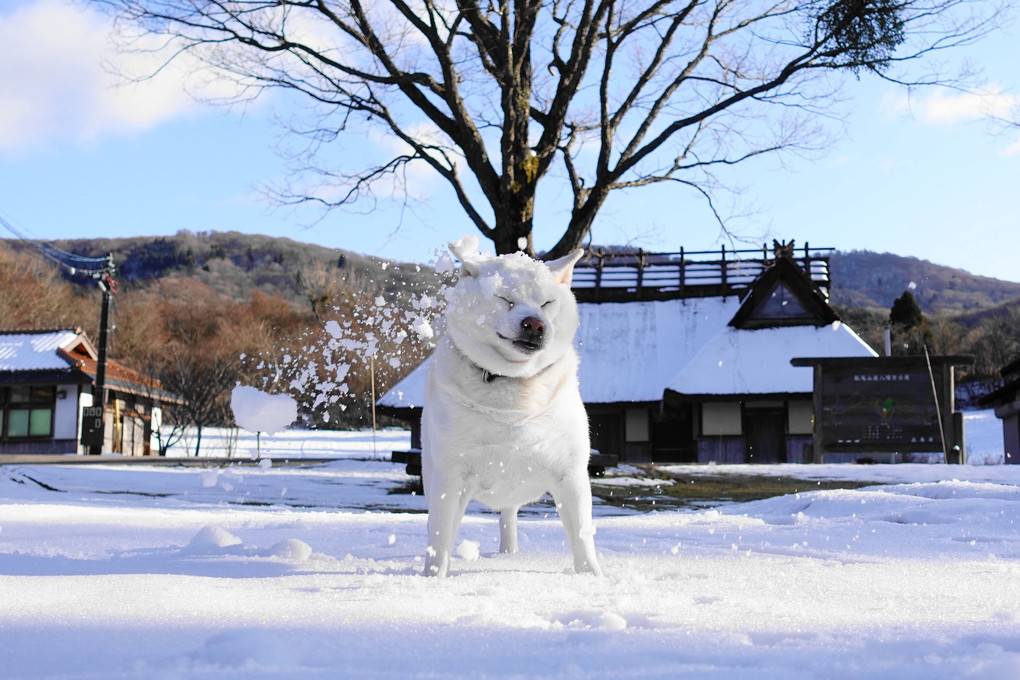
[666, 321, 878, 396]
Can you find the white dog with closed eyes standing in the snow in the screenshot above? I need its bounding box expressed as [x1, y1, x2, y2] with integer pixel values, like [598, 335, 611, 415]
[421, 238, 602, 576]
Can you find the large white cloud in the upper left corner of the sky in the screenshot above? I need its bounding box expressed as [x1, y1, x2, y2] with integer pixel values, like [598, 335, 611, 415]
[0, 0, 237, 153]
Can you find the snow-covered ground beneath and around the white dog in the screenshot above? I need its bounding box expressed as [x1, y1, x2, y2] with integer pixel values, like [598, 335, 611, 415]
[0, 411, 1020, 680]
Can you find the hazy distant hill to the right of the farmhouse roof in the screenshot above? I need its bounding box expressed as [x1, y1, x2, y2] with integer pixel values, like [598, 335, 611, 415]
[829, 251, 1020, 316]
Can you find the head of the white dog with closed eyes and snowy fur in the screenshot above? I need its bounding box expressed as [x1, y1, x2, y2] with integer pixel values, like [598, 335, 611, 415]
[446, 239, 581, 377]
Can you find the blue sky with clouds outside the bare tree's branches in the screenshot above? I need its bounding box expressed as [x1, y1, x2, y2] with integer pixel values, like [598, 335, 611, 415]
[0, 0, 1020, 284]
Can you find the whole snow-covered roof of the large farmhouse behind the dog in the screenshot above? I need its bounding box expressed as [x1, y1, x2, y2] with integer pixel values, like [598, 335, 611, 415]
[378, 297, 877, 408]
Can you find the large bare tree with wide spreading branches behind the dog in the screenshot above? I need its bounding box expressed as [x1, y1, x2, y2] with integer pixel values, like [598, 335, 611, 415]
[99, 0, 997, 258]
